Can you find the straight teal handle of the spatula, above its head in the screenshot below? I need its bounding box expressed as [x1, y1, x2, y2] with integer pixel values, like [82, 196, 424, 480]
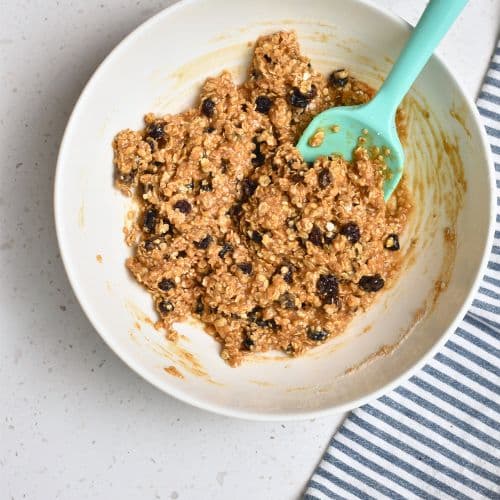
[373, 0, 467, 113]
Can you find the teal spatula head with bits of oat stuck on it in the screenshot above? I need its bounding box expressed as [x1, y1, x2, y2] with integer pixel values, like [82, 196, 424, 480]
[297, 104, 404, 200]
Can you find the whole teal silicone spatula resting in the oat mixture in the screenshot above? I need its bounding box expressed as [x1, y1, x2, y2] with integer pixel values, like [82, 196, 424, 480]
[297, 0, 467, 200]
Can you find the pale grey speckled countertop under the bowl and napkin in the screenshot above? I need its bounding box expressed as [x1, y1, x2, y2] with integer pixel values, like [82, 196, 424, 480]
[0, 0, 500, 500]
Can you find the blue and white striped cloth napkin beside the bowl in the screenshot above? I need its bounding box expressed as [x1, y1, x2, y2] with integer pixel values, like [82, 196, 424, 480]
[305, 41, 500, 500]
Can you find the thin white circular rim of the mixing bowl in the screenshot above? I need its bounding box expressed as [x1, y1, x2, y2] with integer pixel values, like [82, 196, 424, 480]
[53, 0, 496, 422]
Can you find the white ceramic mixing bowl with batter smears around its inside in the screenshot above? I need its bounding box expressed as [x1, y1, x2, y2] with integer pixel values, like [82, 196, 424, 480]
[55, 0, 493, 420]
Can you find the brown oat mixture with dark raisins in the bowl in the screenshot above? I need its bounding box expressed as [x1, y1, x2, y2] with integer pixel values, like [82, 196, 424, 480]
[113, 32, 411, 366]
